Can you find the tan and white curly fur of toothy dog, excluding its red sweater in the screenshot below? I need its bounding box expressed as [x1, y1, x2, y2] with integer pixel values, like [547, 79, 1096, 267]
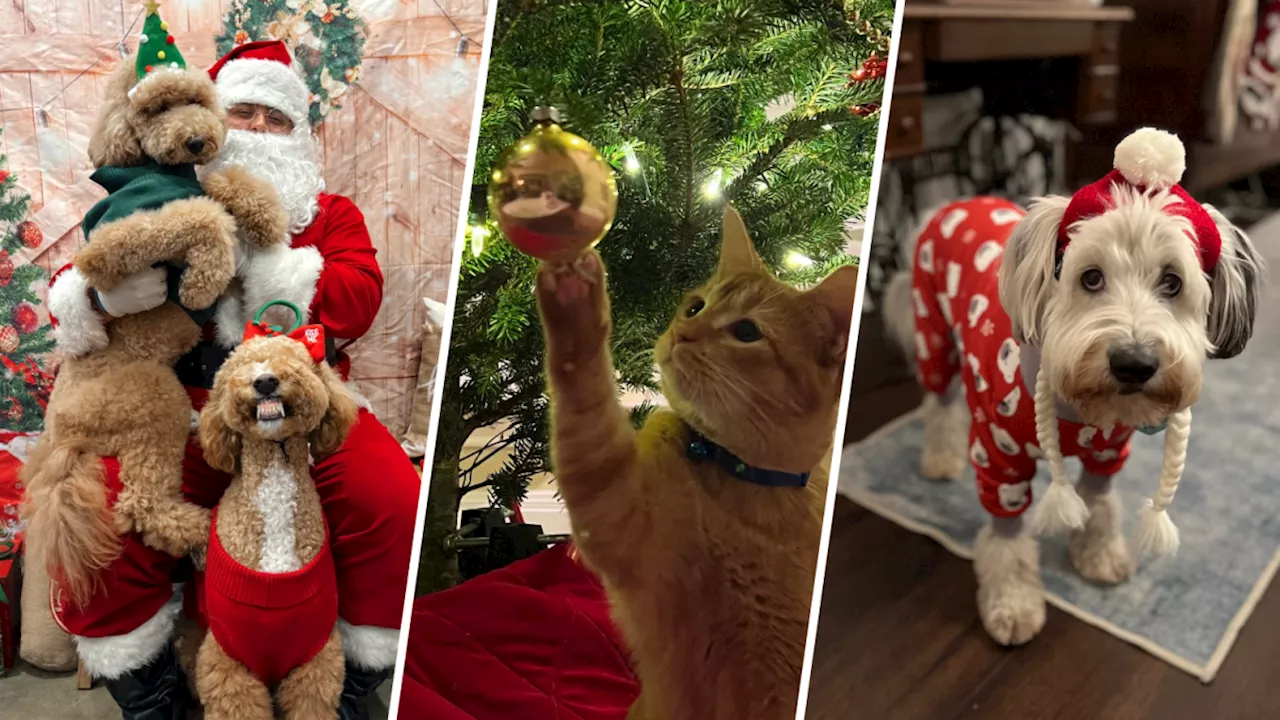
[179, 337, 357, 720]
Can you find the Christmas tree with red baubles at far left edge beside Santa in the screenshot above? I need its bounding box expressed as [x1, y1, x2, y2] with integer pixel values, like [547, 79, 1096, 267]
[0, 131, 54, 432]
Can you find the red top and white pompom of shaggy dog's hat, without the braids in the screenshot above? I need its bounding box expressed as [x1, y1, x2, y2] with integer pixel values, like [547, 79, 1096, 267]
[1055, 128, 1222, 274]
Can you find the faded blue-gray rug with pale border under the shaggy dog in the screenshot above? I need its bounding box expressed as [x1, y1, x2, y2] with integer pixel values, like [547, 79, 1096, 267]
[838, 211, 1280, 683]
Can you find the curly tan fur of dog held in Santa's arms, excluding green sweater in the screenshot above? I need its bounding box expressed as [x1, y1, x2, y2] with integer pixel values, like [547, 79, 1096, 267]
[23, 59, 287, 603]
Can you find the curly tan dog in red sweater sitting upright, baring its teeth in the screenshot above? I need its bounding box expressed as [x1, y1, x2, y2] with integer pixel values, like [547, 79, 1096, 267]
[180, 327, 356, 720]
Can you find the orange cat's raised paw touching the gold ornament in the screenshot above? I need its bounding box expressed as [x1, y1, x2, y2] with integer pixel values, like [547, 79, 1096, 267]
[536, 250, 609, 363]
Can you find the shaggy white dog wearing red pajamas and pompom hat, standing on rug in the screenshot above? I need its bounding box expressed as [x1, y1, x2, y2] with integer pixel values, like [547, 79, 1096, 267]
[884, 128, 1263, 644]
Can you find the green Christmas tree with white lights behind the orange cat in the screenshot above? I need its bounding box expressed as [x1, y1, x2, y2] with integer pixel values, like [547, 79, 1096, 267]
[419, 0, 893, 592]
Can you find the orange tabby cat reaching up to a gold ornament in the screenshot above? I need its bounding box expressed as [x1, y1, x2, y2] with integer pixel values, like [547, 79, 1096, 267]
[538, 208, 858, 720]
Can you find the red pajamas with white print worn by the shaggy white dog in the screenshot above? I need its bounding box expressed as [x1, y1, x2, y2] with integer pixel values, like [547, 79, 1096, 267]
[911, 197, 1133, 518]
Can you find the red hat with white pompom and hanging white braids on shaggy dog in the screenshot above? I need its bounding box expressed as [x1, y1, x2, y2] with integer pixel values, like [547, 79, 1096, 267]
[1032, 128, 1198, 555]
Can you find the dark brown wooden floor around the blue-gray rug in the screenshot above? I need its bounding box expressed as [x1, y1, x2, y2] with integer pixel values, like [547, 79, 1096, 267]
[806, 318, 1280, 720]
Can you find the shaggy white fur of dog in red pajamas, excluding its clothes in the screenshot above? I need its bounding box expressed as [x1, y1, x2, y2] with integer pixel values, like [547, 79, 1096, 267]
[883, 192, 1263, 644]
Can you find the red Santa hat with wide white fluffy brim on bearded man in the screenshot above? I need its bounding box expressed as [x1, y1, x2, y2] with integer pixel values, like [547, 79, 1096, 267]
[209, 40, 311, 128]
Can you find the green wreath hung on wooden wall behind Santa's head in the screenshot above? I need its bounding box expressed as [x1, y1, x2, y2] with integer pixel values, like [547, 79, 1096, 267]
[216, 0, 369, 127]
